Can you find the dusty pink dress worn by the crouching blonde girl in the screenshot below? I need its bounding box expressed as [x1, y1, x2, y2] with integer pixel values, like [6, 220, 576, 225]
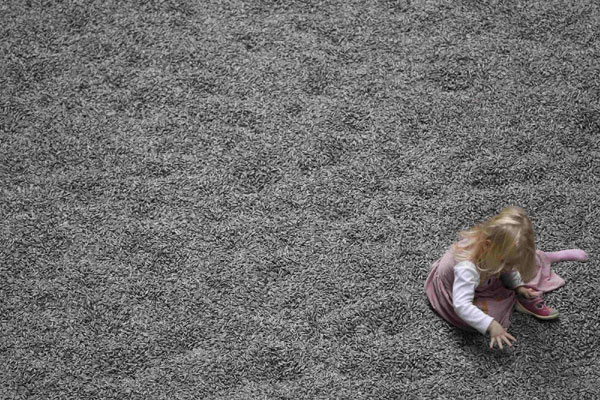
[425, 246, 565, 330]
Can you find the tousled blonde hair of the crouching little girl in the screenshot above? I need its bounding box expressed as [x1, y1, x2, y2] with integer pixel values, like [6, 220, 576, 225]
[454, 206, 537, 282]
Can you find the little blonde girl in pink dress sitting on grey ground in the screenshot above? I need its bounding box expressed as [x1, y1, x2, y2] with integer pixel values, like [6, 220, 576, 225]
[425, 206, 588, 349]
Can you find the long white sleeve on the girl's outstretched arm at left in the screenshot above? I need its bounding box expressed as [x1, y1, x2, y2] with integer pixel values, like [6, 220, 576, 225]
[452, 261, 494, 335]
